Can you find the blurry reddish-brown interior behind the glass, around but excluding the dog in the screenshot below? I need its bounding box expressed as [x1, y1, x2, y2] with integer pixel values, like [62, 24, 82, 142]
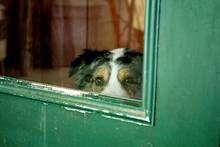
[0, 0, 145, 87]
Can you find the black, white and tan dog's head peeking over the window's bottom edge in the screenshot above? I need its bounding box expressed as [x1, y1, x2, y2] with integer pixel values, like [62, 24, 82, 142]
[69, 48, 142, 98]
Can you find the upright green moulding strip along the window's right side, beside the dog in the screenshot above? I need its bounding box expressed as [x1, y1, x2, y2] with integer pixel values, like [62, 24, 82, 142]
[142, 0, 160, 125]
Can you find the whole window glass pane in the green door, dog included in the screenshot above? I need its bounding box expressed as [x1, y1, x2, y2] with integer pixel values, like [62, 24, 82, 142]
[0, 0, 145, 99]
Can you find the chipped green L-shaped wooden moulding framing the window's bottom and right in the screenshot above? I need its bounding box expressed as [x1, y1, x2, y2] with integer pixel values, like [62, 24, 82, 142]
[0, 0, 159, 126]
